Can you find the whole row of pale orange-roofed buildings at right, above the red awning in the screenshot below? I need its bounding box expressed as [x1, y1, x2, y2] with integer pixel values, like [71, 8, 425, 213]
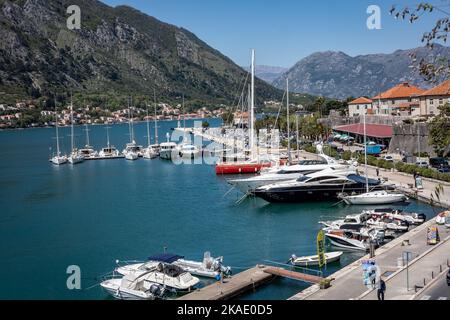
[348, 79, 450, 117]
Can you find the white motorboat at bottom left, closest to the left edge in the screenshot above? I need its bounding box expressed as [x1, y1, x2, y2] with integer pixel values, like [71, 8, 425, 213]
[100, 274, 166, 300]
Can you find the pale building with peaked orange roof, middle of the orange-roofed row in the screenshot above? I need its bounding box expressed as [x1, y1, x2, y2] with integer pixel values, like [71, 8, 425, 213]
[372, 82, 425, 115]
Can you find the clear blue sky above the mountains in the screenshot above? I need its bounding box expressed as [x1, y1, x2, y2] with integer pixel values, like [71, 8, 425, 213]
[102, 0, 450, 67]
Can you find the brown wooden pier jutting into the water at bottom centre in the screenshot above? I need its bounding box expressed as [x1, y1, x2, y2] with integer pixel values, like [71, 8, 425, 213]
[178, 265, 322, 300]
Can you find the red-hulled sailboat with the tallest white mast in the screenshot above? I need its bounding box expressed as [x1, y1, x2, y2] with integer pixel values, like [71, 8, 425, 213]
[216, 50, 272, 175]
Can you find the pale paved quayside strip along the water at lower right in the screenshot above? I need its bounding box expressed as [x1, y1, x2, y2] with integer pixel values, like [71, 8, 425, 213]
[291, 220, 450, 300]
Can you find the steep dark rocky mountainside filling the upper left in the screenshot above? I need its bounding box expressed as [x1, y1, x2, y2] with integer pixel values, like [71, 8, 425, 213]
[0, 0, 282, 104]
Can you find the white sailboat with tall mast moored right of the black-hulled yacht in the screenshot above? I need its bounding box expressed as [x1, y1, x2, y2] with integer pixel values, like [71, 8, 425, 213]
[342, 113, 408, 205]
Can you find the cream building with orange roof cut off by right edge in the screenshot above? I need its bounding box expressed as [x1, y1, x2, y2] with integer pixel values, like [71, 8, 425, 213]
[417, 79, 450, 116]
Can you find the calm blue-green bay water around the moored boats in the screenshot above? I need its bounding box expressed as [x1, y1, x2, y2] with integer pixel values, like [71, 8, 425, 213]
[0, 121, 440, 299]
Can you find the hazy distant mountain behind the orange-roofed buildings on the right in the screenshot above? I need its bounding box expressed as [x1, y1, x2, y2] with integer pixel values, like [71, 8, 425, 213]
[273, 45, 450, 99]
